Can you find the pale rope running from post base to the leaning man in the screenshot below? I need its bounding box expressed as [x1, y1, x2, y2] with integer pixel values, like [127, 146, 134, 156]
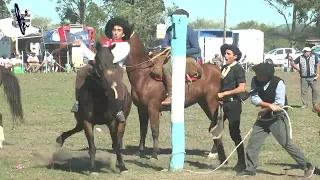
[164, 106, 293, 174]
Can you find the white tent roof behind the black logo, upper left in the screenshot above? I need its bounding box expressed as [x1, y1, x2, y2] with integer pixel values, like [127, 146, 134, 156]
[0, 18, 39, 38]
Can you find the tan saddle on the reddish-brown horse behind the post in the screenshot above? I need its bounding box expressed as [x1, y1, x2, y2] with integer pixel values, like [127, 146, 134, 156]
[149, 49, 203, 82]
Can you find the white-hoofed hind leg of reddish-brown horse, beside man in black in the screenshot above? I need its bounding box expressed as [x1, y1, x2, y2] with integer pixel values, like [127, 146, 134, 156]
[199, 100, 228, 164]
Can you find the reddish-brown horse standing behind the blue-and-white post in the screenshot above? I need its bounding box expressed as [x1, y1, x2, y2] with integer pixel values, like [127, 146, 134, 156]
[126, 34, 222, 159]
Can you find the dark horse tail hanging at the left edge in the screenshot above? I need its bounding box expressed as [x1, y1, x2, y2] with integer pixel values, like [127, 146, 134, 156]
[0, 66, 24, 123]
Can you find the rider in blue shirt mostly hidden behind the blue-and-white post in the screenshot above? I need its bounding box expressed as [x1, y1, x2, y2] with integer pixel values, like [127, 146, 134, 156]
[161, 9, 200, 105]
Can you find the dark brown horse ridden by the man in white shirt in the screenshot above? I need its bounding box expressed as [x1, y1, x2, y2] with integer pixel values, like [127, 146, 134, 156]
[56, 43, 131, 172]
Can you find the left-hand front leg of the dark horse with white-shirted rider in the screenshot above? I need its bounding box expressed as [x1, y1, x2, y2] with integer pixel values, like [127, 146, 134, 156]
[83, 120, 96, 172]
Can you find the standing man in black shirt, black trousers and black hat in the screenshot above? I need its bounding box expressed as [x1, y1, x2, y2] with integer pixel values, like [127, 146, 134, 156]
[209, 44, 246, 172]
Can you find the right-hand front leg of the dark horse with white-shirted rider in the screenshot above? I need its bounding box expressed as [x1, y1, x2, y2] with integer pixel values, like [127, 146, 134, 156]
[108, 121, 128, 172]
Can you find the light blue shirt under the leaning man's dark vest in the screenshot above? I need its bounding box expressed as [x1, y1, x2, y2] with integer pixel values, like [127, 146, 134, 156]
[251, 80, 286, 107]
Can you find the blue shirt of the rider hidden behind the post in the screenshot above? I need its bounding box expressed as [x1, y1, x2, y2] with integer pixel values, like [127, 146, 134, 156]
[161, 26, 200, 55]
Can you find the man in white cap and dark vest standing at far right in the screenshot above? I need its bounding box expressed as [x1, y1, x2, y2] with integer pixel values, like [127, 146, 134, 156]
[291, 47, 319, 109]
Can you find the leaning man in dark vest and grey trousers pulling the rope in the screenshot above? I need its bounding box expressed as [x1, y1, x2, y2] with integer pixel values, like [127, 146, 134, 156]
[238, 63, 315, 178]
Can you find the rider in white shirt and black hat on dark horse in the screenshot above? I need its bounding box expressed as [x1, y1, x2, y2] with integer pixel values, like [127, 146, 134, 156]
[71, 18, 132, 122]
